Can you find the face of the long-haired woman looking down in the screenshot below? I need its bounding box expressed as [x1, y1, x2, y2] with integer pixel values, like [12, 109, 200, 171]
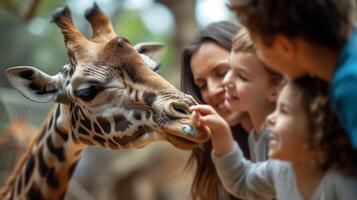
[191, 41, 241, 126]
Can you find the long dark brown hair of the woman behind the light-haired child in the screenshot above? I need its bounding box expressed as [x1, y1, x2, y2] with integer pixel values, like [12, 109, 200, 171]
[181, 22, 249, 200]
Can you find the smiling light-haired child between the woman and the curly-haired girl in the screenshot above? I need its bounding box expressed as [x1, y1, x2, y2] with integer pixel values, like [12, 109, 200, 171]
[214, 28, 284, 162]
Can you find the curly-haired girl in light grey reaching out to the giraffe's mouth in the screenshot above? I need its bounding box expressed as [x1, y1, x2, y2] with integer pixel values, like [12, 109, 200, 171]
[191, 76, 357, 200]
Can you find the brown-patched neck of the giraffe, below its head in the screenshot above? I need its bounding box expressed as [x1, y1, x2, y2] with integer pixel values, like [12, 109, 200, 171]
[9, 105, 86, 199]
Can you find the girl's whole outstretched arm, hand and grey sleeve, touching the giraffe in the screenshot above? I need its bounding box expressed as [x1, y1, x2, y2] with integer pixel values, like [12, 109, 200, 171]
[190, 105, 277, 199]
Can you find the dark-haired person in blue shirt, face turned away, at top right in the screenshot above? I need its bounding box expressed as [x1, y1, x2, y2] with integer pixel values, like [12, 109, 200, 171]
[230, 0, 357, 148]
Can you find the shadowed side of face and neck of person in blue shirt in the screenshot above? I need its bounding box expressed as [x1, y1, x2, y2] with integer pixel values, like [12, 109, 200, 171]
[251, 33, 306, 79]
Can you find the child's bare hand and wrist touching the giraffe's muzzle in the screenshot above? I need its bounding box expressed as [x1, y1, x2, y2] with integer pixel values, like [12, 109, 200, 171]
[190, 105, 234, 155]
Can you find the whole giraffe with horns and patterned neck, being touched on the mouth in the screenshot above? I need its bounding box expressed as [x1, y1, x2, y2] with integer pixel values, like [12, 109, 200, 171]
[0, 4, 209, 199]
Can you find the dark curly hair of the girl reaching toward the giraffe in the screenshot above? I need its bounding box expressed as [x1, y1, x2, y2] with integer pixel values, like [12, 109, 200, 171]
[292, 76, 357, 174]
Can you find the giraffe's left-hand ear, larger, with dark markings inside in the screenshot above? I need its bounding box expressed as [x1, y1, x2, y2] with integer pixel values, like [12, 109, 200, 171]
[5, 66, 58, 103]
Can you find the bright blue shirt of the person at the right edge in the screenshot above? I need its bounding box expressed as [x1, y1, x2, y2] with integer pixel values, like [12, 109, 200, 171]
[330, 30, 357, 148]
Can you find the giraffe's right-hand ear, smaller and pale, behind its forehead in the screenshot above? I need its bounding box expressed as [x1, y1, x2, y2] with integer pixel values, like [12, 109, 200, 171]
[134, 42, 165, 71]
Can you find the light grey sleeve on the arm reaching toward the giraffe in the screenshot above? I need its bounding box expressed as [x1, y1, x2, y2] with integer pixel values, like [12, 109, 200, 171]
[211, 143, 276, 199]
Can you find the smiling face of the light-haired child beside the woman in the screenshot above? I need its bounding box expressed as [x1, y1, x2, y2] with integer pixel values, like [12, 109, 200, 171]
[224, 53, 271, 113]
